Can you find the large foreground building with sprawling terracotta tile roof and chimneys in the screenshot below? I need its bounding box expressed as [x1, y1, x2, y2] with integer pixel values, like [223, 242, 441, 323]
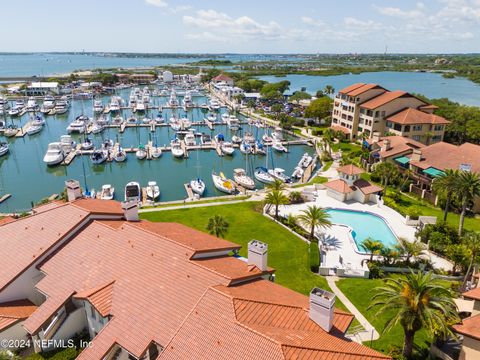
[0, 180, 389, 360]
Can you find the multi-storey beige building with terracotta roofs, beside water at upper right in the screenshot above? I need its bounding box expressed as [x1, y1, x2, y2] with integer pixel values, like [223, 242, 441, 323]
[332, 83, 449, 145]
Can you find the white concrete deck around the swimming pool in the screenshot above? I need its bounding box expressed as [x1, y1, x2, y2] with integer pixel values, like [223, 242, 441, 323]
[280, 190, 451, 270]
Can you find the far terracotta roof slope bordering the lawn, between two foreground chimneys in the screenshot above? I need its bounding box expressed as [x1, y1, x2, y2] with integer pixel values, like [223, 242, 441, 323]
[132, 221, 241, 252]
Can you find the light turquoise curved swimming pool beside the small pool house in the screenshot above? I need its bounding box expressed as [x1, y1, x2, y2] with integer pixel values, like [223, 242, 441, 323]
[326, 209, 398, 253]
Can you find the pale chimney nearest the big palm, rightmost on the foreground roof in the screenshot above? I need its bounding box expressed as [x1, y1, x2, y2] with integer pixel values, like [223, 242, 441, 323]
[310, 288, 336, 332]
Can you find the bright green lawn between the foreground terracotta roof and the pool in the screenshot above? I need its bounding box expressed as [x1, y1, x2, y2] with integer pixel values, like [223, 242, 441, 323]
[140, 202, 332, 298]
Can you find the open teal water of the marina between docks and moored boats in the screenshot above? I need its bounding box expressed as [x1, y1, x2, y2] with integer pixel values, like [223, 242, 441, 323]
[0, 90, 313, 212]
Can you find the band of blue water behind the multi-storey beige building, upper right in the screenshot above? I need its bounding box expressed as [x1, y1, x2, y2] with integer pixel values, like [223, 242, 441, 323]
[259, 71, 480, 106]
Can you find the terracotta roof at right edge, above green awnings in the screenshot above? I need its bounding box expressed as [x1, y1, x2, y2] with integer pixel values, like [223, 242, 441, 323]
[410, 141, 480, 173]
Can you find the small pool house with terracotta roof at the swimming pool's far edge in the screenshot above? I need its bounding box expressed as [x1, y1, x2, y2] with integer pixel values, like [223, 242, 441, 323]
[324, 164, 382, 204]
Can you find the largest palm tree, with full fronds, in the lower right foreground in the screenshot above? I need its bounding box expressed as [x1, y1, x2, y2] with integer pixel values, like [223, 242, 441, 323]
[367, 271, 458, 359]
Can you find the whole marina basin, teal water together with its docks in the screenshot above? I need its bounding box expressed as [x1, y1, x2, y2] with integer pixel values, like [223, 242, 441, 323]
[0, 84, 314, 213]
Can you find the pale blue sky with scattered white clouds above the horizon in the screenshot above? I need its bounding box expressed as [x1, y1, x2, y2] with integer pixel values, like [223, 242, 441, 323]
[0, 0, 480, 53]
